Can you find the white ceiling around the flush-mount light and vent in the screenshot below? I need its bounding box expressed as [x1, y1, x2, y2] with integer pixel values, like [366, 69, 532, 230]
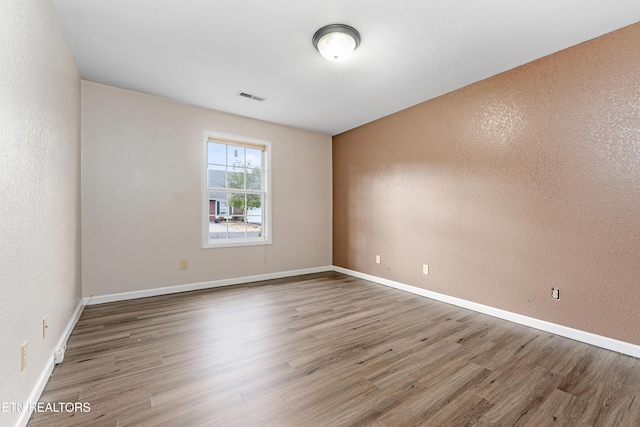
[53, 0, 640, 135]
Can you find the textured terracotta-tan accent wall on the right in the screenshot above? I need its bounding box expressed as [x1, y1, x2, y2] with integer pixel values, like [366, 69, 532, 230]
[333, 24, 640, 344]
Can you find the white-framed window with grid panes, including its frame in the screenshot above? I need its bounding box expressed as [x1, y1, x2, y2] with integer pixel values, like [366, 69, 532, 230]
[202, 131, 271, 248]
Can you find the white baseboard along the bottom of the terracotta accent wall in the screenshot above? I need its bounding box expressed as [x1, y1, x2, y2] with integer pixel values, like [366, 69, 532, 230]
[333, 266, 640, 358]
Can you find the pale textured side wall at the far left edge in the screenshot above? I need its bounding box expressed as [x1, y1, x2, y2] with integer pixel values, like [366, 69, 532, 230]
[0, 0, 81, 426]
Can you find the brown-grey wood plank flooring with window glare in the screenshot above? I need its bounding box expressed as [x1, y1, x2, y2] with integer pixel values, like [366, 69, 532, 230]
[29, 273, 640, 427]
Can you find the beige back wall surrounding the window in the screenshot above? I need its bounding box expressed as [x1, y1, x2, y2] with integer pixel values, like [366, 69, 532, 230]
[82, 81, 332, 296]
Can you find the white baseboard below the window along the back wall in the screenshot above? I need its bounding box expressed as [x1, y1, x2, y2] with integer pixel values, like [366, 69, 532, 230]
[83, 265, 333, 305]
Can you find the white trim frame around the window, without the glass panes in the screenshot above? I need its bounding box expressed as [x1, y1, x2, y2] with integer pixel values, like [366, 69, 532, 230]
[200, 130, 273, 249]
